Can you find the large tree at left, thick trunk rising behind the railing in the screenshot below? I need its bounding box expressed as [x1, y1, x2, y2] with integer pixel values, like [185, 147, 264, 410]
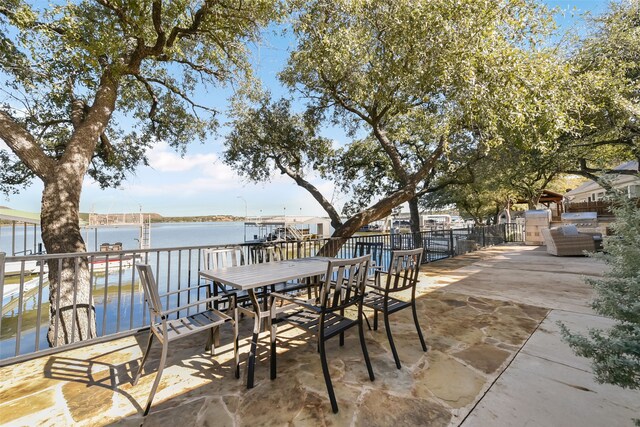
[0, 0, 279, 345]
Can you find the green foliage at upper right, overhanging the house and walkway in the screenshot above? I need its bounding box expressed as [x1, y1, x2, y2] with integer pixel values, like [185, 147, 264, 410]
[425, 1, 640, 218]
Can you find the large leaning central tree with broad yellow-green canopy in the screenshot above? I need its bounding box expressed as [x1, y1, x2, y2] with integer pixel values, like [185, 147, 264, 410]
[226, 0, 564, 254]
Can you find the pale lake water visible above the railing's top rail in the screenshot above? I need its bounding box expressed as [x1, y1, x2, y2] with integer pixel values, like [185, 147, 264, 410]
[0, 222, 249, 255]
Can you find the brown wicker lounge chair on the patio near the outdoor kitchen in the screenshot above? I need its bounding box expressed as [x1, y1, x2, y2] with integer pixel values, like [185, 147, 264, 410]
[540, 225, 602, 256]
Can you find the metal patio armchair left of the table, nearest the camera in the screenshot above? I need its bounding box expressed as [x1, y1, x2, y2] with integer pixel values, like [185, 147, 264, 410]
[133, 264, 240, 416]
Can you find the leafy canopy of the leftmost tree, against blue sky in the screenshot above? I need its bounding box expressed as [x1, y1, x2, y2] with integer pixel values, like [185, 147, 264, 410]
[0, 0, 281, 192]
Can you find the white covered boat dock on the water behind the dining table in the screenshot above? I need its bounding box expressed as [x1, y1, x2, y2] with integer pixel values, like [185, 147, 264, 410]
[244, 216, 331, 243]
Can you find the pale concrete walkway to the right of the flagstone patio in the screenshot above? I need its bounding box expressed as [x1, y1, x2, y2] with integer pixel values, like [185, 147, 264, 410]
[430, 247, 640, 427]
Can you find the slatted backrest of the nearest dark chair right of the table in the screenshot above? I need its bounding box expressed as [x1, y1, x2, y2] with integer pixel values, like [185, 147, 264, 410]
[319, 255, 371, 314]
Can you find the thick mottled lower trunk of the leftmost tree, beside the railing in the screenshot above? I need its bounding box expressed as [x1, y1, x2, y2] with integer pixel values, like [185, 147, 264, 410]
[41, 173, 96, 347]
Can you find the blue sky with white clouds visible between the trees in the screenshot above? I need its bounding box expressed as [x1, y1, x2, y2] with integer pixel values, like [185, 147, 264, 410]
[0, 0, 607, 216]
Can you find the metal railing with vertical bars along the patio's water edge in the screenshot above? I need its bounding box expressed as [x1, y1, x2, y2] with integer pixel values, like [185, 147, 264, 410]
[0, 224, 524, 366]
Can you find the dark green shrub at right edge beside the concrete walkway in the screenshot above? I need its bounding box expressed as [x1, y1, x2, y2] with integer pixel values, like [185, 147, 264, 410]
[562, 186, 640, 389]
